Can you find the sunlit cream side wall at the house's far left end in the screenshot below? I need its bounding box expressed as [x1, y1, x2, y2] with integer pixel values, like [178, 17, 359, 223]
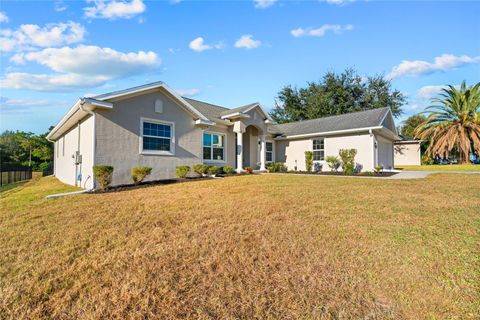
[54, 116, 94, 189]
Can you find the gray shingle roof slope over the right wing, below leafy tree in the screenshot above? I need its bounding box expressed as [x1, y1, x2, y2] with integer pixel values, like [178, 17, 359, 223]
[274, 108, 389, 136]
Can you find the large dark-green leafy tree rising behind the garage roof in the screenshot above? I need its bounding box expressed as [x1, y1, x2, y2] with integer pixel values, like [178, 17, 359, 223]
[270, 69, 405, 123]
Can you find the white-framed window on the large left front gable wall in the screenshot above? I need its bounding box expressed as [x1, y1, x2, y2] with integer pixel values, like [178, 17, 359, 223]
[141, 120, 173, 154]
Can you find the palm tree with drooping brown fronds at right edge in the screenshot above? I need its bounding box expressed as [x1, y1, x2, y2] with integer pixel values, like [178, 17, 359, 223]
[415, 81, 480, 162]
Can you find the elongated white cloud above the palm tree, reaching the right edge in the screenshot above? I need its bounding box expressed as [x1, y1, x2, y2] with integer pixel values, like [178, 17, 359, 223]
[387, 54, 480, 79]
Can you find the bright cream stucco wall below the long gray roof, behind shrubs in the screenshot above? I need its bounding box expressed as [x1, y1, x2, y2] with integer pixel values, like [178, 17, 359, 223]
[275, 133, 373, 171]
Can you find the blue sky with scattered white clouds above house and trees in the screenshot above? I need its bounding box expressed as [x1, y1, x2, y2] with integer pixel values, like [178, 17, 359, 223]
[0, 0, 480, 133]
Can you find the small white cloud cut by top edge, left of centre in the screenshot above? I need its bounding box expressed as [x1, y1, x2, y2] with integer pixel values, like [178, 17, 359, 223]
[83, 0, 147, 20]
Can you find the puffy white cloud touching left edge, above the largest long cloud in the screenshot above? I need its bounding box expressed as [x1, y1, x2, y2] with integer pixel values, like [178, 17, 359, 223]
[0, 21, 86, 51]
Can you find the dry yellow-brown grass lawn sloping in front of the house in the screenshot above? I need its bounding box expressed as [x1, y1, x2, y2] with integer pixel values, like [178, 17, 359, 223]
[0, 174, 480, 319]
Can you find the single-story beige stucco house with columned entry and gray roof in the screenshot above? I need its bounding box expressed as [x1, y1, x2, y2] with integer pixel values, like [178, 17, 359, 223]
[47, 82, 399, 188]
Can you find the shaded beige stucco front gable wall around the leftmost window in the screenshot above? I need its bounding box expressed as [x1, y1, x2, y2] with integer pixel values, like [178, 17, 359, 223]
[95, 92, 203, 185]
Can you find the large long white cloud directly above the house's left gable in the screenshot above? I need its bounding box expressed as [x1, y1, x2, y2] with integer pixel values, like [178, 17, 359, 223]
[10, 45, 161, 79]
